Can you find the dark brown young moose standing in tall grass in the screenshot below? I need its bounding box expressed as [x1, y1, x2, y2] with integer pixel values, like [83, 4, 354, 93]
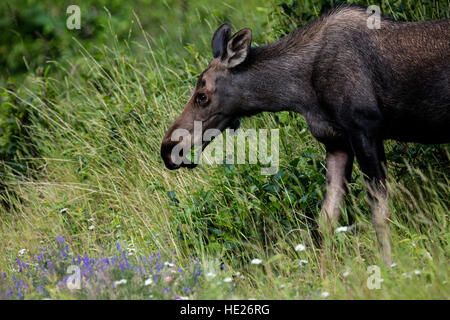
[161, 5, 450, 266]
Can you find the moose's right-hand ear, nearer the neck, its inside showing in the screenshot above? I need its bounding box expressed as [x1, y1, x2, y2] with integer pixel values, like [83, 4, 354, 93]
[222, 28, 252, 68]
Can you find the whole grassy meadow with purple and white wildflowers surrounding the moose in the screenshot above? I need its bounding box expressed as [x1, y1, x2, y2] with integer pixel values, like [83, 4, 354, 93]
[0, 0, 450, 299]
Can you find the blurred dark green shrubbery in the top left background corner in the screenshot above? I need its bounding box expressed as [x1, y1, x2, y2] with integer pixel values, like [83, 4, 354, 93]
[0, 0, 149, 83]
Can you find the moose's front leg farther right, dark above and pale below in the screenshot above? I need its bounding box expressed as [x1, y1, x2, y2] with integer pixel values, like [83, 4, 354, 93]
[351, 132, 392, 266]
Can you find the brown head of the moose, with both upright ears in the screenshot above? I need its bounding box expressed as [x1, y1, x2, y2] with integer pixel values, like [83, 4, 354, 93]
[161, 23, 252, 170]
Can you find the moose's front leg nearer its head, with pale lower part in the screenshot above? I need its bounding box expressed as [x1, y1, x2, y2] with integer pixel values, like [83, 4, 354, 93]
[320, 146, 354, 230]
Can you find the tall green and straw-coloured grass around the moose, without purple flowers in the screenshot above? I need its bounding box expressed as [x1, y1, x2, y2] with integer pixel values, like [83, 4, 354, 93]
[0, 1, 450, 299]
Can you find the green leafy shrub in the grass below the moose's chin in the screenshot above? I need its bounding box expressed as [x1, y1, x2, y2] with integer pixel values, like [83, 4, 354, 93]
[167, 146, 325, 254]
